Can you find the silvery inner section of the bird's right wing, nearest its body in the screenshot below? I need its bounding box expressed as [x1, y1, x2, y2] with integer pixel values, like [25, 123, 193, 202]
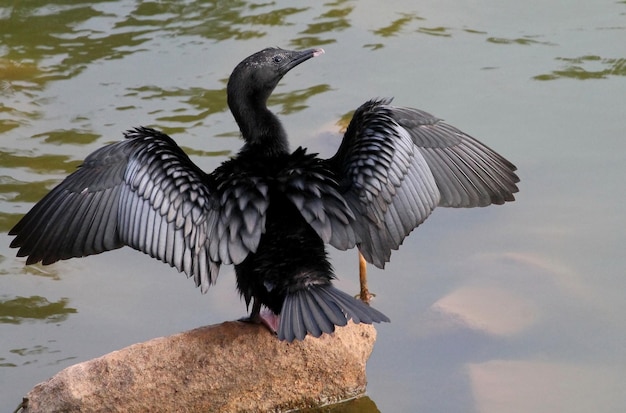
[328, 101, 440, 268]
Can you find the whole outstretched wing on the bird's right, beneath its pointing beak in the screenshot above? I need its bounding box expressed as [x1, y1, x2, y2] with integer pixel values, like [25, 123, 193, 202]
[328, 100, 519, 268]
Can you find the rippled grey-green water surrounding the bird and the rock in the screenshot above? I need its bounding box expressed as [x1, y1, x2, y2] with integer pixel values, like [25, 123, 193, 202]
[0, 0, 626, 413]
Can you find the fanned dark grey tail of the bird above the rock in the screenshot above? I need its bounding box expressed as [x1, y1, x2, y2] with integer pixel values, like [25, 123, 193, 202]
[278, 285, 389, 342]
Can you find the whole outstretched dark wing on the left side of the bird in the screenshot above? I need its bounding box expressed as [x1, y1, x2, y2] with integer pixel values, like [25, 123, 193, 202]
[9, 128, 267, 292]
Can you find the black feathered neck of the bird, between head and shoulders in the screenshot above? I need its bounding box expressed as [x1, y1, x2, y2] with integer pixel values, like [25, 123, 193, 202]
[230, 98, 289, 157]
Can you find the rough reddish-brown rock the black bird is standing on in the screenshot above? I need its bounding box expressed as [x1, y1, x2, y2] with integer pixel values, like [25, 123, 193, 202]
[22, 321, 376, 413]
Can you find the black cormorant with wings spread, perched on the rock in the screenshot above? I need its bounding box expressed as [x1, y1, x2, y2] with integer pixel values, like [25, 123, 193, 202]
[10, 48, 519, 341]
